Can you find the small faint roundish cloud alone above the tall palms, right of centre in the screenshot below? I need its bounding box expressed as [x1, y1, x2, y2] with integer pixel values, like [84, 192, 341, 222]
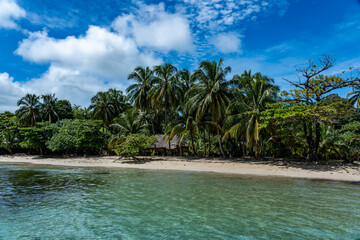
[212, 32, 242, 53]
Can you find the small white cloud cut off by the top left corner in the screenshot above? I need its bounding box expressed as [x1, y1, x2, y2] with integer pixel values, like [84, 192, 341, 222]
[0, 0, 26, 29]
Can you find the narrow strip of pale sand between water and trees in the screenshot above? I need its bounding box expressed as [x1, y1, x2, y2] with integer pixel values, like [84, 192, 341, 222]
[0, 156, 360, 182]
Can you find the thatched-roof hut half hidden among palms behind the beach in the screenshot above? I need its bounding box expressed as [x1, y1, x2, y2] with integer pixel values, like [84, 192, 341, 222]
[148, 135, 189, 155]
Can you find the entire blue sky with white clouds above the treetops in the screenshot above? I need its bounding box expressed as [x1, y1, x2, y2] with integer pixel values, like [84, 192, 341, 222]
[0, 0, 360, 112]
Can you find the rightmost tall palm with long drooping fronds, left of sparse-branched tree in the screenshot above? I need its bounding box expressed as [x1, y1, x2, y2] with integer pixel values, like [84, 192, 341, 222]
[224, 71, 279, 154]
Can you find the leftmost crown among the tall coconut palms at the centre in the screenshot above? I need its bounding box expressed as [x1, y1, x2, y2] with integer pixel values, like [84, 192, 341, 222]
[126, 66, 154, 109]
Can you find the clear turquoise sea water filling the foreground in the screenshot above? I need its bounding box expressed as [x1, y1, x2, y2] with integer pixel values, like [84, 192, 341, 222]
[0, 165, 360, 239]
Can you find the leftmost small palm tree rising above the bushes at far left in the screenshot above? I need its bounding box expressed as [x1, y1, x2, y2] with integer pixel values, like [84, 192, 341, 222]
[16, 93, 40, 126]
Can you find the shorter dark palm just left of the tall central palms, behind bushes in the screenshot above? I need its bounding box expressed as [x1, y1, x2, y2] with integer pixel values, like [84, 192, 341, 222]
[90, 92, 116, 127]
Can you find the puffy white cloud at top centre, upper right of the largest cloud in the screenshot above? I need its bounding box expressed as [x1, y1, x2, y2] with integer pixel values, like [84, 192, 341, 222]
[112, 3, 193, 52]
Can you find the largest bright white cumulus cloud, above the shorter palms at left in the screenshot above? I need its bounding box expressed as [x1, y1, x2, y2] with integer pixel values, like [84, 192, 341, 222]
[11, 26, 162, 106]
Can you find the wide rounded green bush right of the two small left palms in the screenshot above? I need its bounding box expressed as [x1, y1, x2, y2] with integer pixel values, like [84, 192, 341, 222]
[46, 120, 106, 151]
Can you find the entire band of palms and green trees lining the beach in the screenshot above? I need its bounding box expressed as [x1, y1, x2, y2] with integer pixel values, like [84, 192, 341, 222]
[0, 56, 360, 161]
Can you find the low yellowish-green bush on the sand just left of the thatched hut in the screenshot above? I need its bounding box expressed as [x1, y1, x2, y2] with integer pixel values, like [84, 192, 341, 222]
[112, 134, 157, 157]
